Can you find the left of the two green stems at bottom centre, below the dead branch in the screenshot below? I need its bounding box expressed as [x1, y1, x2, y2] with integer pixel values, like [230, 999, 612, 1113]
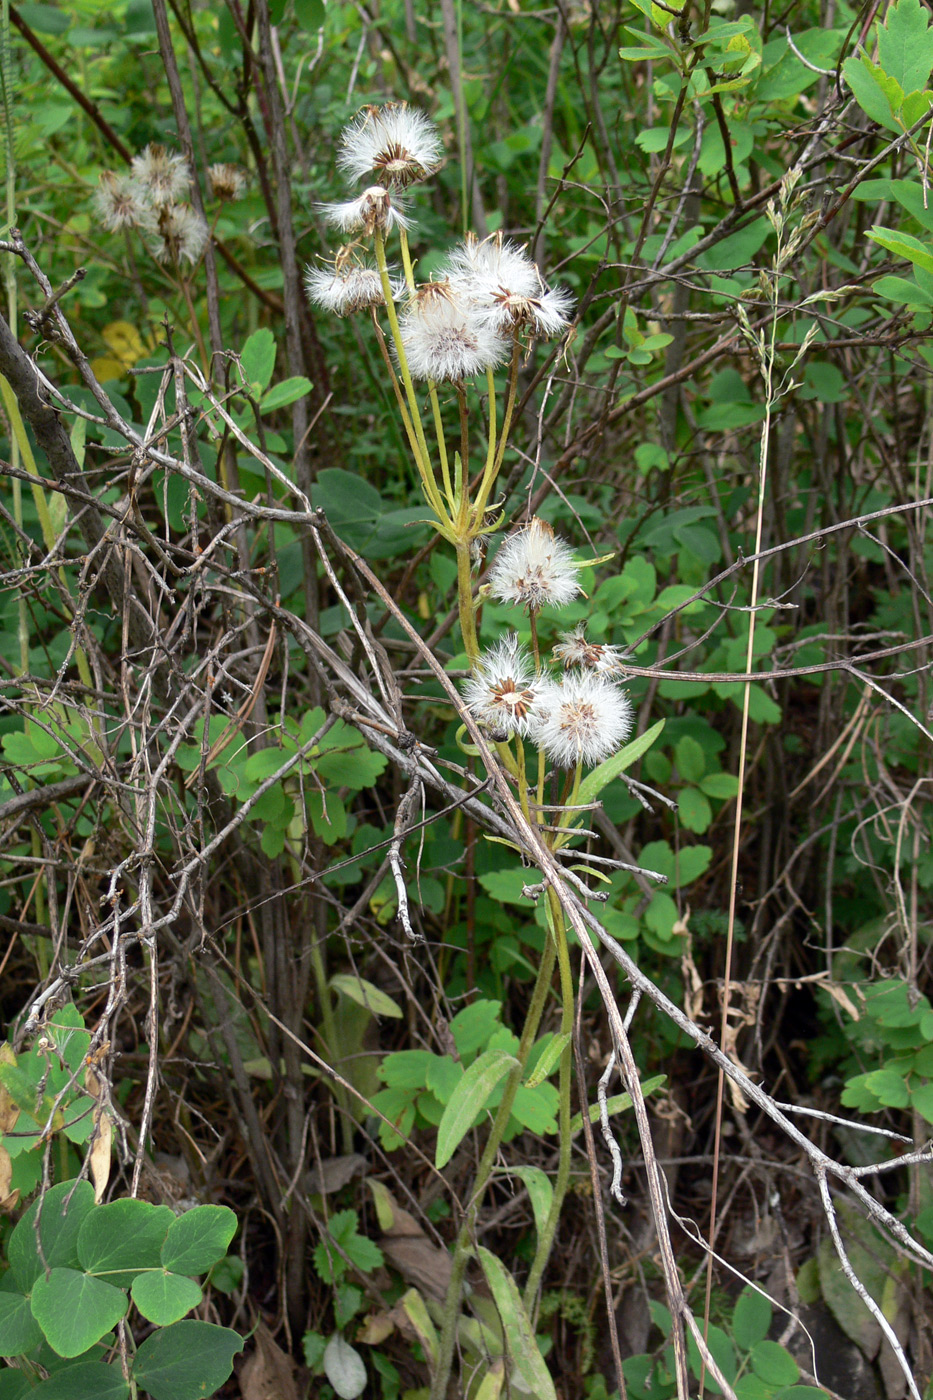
[430, 938, 556, 1400]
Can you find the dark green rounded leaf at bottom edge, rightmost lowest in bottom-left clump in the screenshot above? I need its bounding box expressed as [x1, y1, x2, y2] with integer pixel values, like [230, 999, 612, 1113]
[133, 1321, 244, 1400]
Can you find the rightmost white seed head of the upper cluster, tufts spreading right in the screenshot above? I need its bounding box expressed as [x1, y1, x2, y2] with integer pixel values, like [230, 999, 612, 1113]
[445, 234, 573, 339]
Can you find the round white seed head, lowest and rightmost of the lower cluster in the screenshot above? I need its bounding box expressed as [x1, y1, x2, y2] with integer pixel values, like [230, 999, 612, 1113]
[528, 671, 633, 769]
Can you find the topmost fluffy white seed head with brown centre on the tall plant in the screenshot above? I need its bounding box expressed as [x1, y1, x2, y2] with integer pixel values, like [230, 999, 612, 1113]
[338, 102, 443, 189]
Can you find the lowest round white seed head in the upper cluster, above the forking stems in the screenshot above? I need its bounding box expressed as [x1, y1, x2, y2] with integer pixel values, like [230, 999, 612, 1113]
[402, 292, 509, 384]
